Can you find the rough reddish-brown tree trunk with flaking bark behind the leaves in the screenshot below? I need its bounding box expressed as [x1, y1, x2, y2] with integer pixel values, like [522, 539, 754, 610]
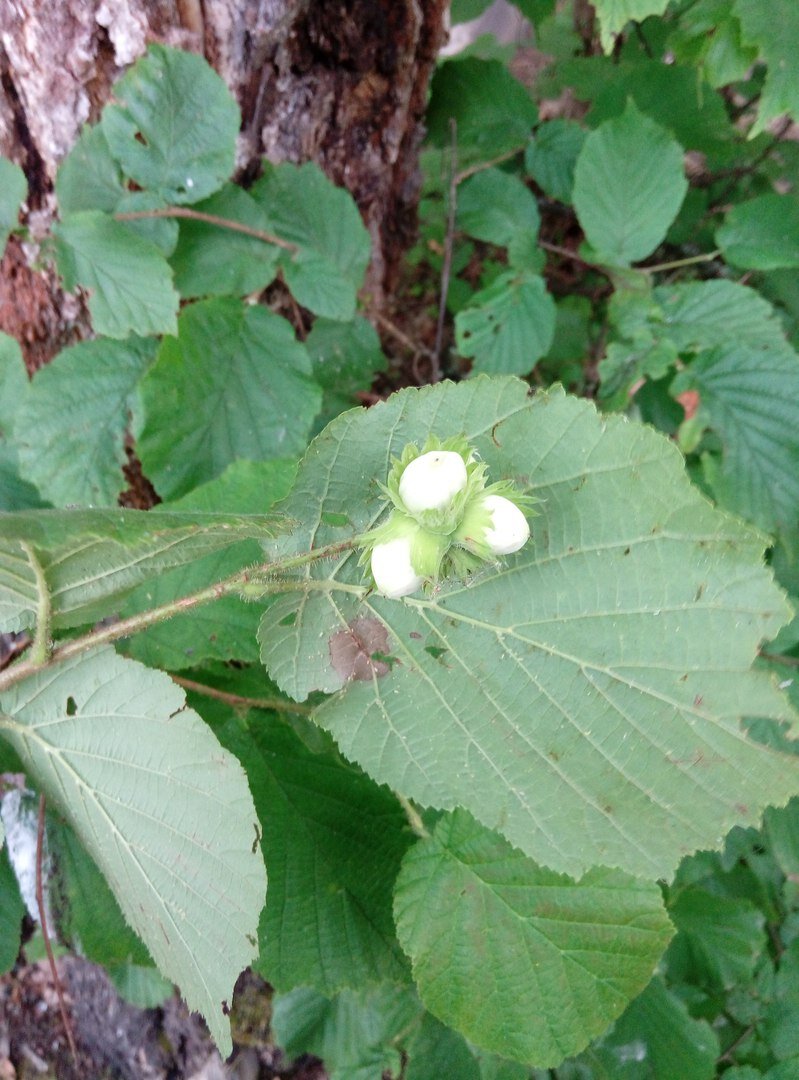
[0, 0, 448, 367]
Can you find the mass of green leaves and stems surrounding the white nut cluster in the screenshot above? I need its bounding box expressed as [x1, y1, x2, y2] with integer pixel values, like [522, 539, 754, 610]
[0, 14, 799, 1080]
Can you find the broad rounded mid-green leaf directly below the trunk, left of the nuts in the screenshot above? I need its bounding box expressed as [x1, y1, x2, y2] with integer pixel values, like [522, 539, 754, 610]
[137, 298, 322, 499]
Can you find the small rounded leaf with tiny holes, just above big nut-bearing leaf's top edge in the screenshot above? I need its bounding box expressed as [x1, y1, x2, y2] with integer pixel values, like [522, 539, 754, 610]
[455, 271, 555, 375]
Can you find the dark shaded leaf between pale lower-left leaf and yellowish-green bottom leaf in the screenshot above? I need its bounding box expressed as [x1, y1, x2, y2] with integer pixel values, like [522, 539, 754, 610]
[220, 713, 412, 996]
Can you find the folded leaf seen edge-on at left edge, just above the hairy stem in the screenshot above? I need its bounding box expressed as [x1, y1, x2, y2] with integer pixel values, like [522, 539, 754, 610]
[0, 510, 276, 631]
